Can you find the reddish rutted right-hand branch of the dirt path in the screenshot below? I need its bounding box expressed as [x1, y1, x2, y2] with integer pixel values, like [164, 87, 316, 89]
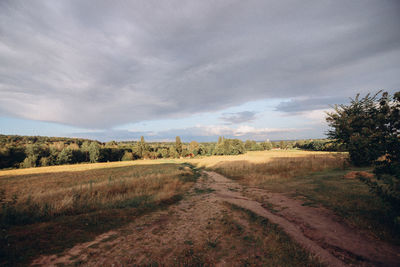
[205, 172, 400, 266]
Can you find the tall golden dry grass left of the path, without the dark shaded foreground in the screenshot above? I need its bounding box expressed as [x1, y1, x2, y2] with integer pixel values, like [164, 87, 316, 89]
[0, 164, 193, 225]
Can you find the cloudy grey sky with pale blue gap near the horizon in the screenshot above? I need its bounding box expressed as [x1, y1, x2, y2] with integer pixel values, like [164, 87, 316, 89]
[0, 0, 400, 142]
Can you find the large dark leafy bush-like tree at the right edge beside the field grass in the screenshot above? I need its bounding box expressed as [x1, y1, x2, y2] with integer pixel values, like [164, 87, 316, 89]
[327, 92, 400, 212]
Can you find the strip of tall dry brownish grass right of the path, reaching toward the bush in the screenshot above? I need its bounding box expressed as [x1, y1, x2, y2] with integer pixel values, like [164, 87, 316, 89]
[211, 154, 348, 185]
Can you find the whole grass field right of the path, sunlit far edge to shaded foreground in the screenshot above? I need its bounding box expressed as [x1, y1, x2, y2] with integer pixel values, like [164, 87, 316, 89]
[205, 152, 400, 244]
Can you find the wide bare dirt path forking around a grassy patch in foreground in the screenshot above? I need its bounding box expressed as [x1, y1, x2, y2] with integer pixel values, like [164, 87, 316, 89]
[32, 172, 400, 266]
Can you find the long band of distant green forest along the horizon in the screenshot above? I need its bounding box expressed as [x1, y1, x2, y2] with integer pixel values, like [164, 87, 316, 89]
[0, 135, 339, 169]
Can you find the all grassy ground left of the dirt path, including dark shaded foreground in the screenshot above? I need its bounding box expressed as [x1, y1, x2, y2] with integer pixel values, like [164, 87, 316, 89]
[0, 164, 196, 265]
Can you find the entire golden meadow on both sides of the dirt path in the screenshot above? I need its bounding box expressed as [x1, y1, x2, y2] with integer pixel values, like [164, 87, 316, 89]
[0, 150, 400, 266]
